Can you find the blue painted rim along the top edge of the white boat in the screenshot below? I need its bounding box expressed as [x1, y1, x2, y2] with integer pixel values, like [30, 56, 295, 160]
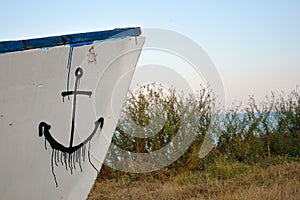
[0, 28, 141, 53]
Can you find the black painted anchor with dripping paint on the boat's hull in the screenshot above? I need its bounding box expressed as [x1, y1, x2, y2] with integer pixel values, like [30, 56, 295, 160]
[38, 67, 104, 187]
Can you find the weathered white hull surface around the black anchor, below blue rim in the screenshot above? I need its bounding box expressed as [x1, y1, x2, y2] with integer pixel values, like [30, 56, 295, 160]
[0, 36, 144, 199]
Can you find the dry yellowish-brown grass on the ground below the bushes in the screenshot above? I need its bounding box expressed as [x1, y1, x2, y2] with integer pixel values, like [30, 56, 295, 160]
[88, 162, 300, 200]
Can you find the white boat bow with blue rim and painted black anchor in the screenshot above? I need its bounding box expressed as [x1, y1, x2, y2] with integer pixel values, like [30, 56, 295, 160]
[0, 28, 145, 199]
